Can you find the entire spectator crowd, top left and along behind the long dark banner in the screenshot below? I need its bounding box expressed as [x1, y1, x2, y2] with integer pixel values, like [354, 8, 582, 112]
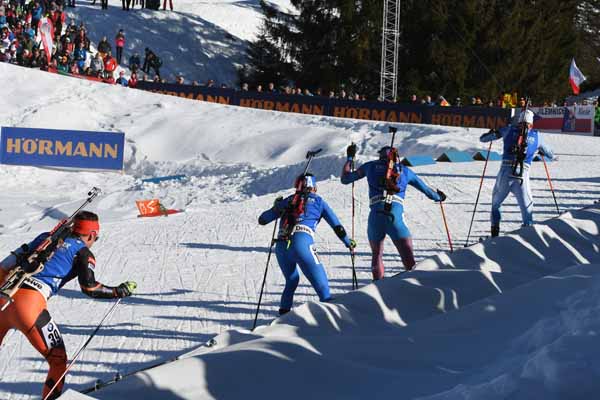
[0, 0, 592, 108]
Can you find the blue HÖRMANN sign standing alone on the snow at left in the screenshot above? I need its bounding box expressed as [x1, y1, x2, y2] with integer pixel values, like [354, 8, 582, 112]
[0, 127, 125, 170]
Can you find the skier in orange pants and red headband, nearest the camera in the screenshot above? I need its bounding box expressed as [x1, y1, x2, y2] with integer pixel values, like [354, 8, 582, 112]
[0, 208, 137, 399]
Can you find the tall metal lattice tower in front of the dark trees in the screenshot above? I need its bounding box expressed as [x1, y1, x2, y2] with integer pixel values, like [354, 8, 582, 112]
[379, 0, 400, 101]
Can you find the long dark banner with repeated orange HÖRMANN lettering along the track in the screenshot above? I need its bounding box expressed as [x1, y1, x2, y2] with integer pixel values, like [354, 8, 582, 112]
[137, 81, 511, 129]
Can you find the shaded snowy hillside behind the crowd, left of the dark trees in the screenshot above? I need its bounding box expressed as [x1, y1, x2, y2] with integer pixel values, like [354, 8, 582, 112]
[66, 0, 291, 86]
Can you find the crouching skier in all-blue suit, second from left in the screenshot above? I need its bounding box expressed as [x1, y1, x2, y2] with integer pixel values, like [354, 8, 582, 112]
[258, 174, 356, 315]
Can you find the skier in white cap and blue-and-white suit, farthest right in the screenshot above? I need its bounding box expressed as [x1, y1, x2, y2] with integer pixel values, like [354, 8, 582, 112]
[479, 110, 556, 236]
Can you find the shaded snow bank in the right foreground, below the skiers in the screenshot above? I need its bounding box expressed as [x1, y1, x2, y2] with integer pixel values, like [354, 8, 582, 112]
[94, 206, 600, 400]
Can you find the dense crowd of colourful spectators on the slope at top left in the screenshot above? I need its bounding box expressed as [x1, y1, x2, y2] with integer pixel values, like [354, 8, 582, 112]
[0, 0, 169, 86]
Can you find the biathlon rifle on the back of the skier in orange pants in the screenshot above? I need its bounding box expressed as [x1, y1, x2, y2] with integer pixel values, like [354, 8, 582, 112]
[0, 187, 100, 311]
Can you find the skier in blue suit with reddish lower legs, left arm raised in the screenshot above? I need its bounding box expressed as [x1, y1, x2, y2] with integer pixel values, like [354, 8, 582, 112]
[341, 144, 446, 280]
